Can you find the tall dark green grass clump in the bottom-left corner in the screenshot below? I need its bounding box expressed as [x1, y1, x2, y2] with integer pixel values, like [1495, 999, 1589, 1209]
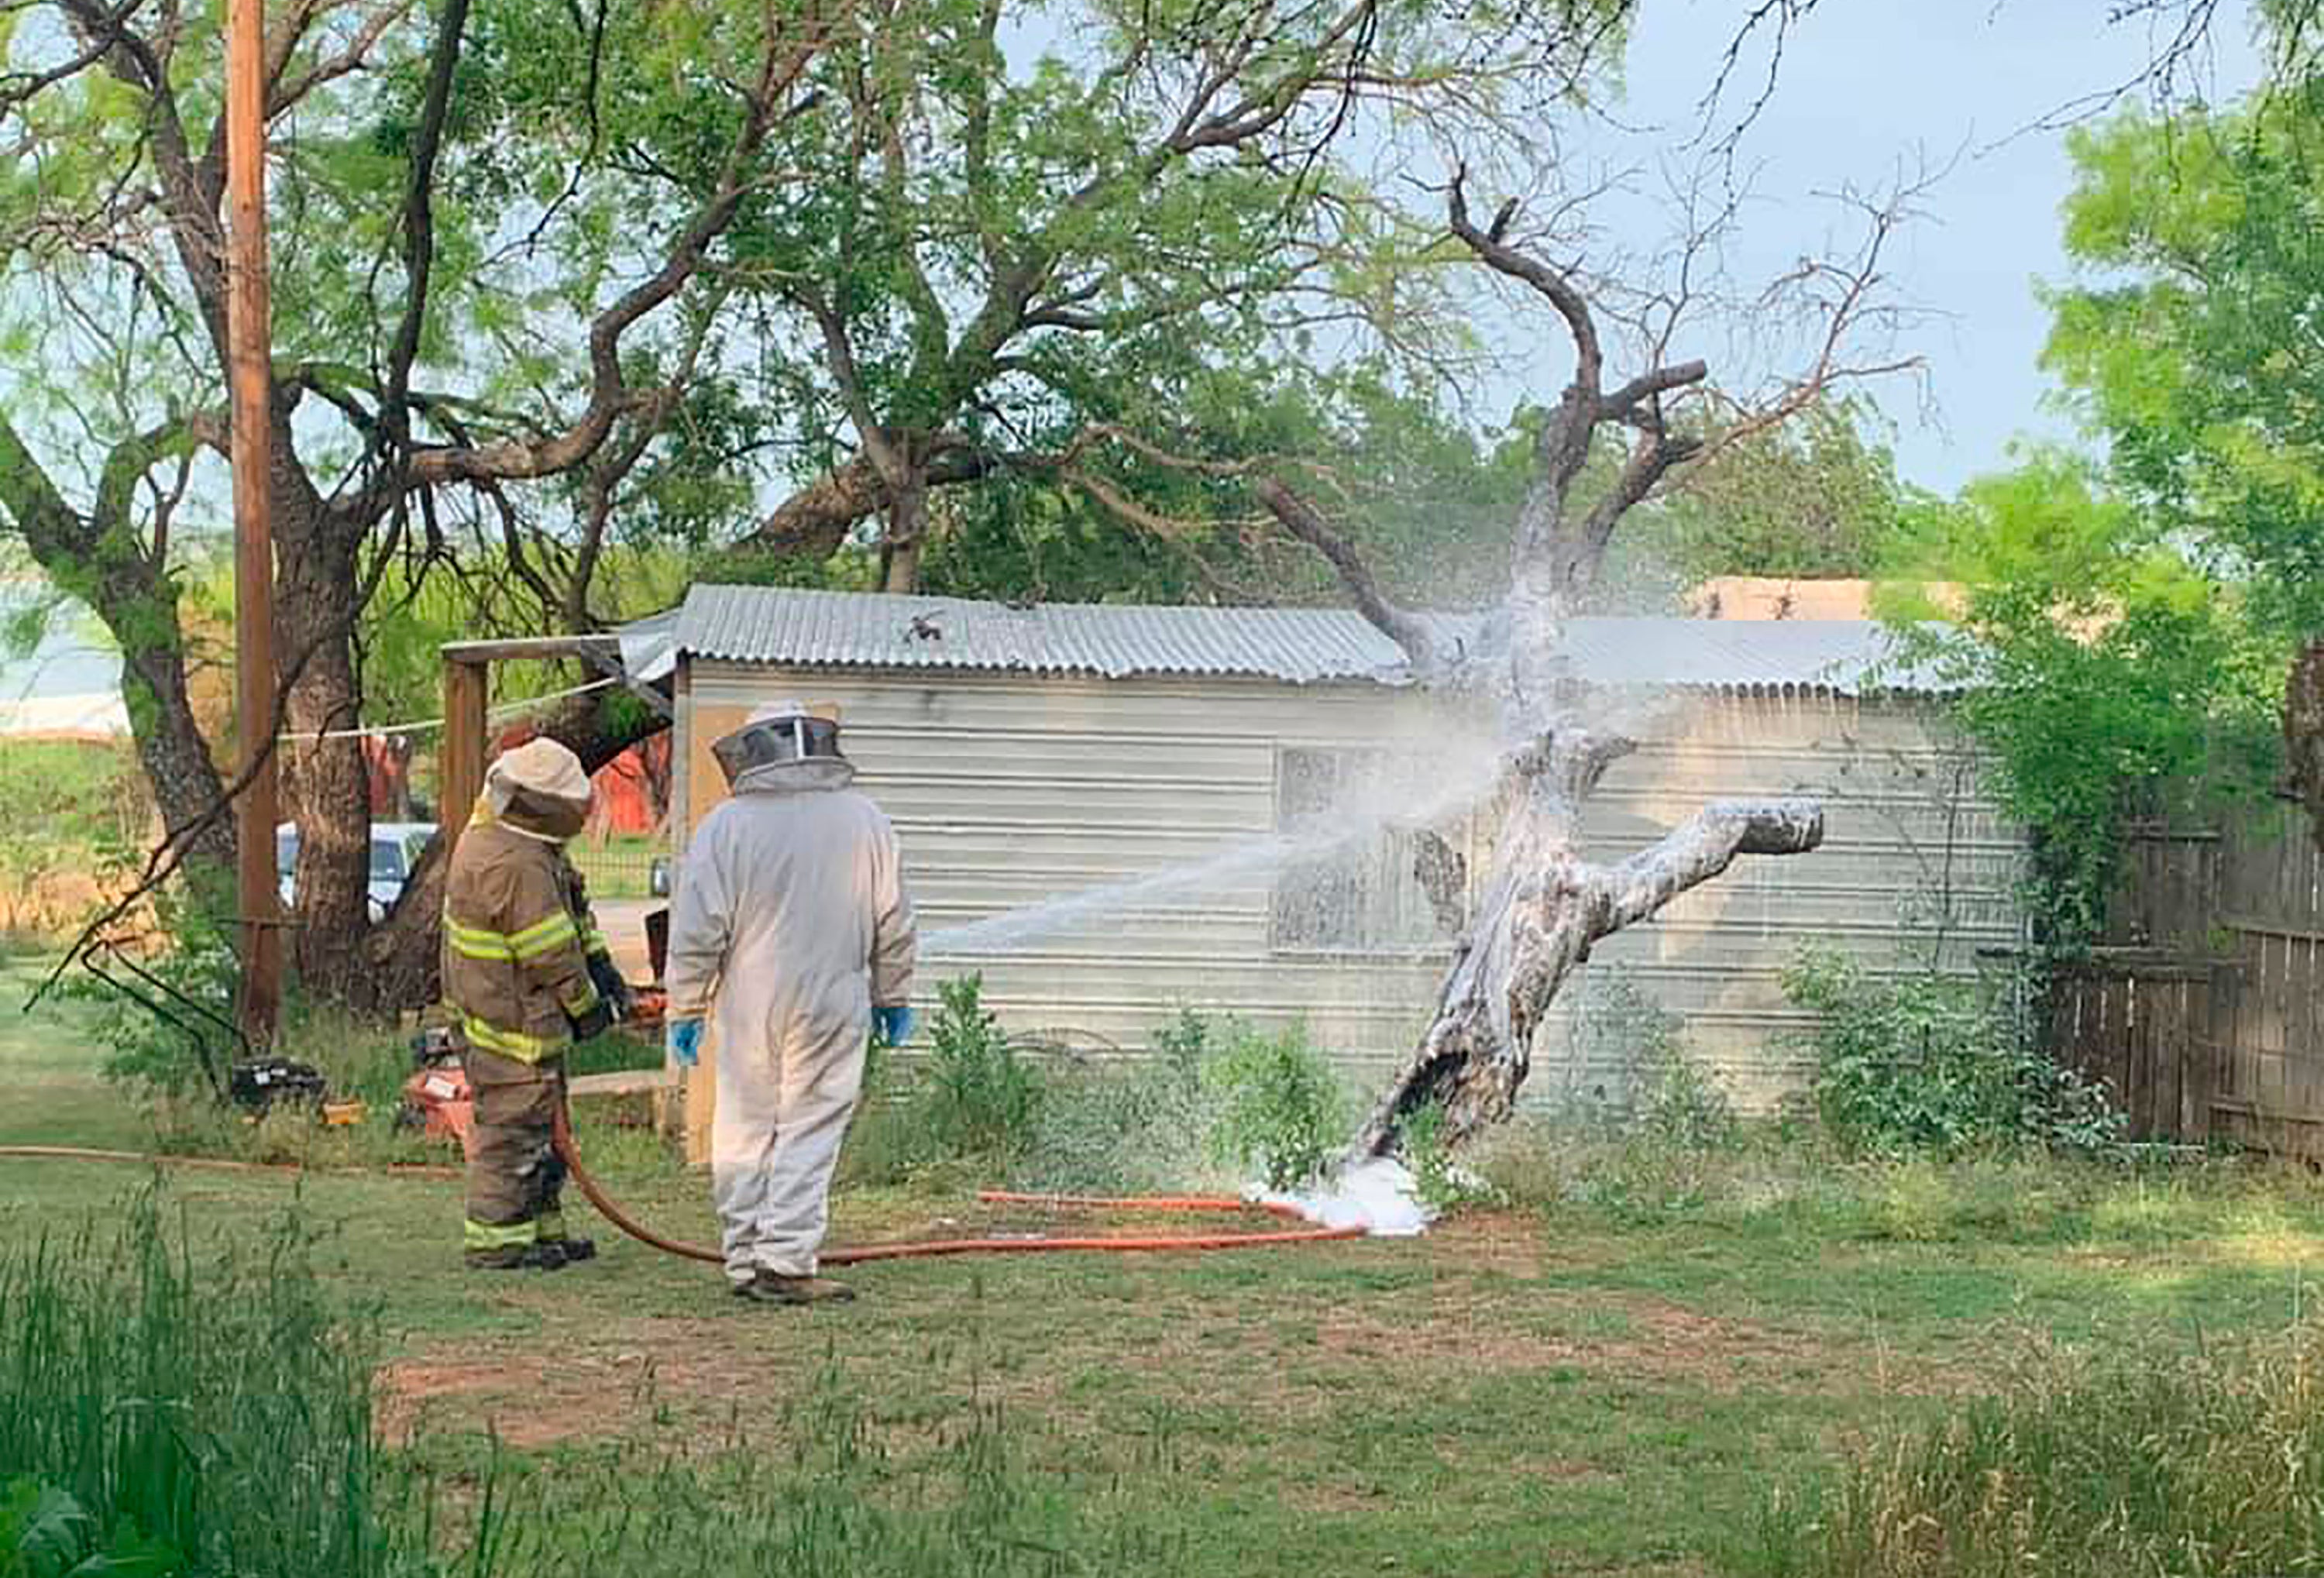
[0, 1195, 414, 1578]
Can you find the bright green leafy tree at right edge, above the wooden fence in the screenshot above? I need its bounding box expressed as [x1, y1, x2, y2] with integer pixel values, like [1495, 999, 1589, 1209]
[2047, 70, 2324, 837]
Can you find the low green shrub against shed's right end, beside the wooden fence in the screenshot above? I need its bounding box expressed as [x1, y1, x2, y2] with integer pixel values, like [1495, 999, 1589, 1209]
[1785, 951, 2122, 1155]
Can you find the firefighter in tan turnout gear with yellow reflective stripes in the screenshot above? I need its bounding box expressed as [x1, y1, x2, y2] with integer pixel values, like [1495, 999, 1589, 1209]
[444, 739, 630, 1271]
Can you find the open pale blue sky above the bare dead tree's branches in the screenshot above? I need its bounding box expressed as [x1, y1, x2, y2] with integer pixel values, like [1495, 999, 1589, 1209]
[1569, 0, 2259, 493]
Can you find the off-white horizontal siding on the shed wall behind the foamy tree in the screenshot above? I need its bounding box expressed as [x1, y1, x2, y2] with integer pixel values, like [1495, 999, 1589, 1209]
[679, 660, 2017, 1106]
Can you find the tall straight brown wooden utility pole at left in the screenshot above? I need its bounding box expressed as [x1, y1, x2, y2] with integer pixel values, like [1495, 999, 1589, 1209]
[225, 0, 284, 1046]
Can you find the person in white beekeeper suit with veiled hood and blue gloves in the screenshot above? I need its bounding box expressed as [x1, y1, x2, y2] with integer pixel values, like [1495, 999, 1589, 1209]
[667, 702, 916, 1304]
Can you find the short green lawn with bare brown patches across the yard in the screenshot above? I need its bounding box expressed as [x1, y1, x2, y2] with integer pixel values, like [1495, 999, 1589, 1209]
[0, 995, 2324, 1578]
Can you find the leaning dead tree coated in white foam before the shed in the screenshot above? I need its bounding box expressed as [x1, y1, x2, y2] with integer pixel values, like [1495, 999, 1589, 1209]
[1255, 177, 1913, 1153]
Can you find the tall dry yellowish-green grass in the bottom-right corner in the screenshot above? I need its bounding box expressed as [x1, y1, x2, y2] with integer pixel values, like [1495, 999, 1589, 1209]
[1738, 1334, 2324, 1578]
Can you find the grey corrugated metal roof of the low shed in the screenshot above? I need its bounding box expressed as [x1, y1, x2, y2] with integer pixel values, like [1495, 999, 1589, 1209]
[676, 586, 1945, 695]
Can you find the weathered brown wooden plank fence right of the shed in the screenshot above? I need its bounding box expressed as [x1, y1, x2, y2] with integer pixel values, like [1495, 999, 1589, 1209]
[2052, 806, 2324, 1160]
